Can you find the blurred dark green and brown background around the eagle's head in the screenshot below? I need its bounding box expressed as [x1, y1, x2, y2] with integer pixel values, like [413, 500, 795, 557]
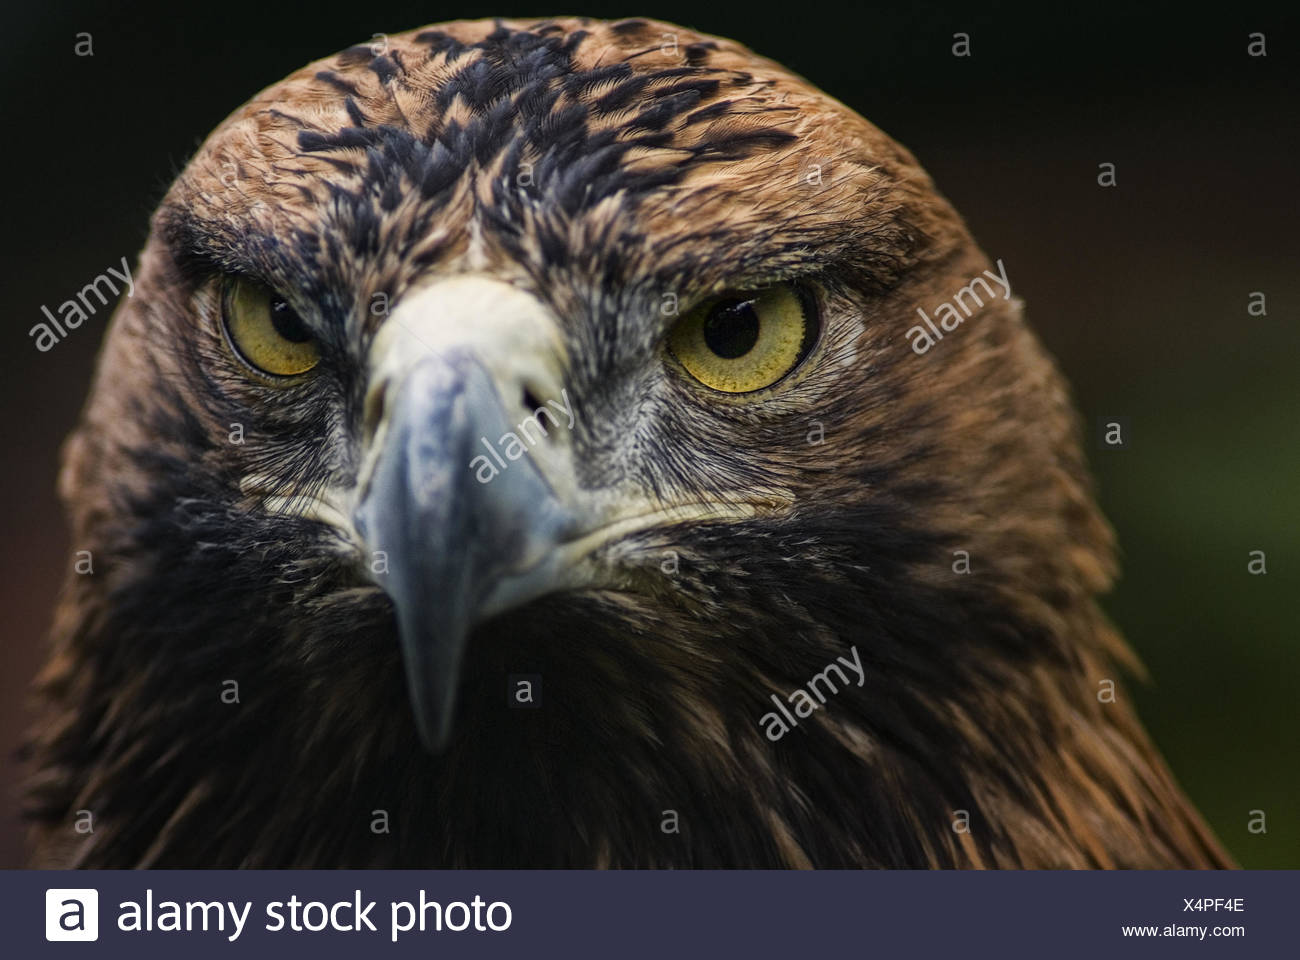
[0, 0, 1300, 868]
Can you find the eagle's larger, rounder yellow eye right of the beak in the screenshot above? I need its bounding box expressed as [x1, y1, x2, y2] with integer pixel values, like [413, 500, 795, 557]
[668, 284, 818, 393]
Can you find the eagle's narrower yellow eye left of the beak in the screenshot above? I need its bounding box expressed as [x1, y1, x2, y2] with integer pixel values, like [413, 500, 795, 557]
[221, 277, 320, 377]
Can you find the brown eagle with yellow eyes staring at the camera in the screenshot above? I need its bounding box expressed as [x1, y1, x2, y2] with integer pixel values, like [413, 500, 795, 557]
[27, 18, 1230, 868]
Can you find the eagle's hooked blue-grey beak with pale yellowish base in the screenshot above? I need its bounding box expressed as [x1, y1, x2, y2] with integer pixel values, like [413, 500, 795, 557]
[354, 276, 586, 751]
